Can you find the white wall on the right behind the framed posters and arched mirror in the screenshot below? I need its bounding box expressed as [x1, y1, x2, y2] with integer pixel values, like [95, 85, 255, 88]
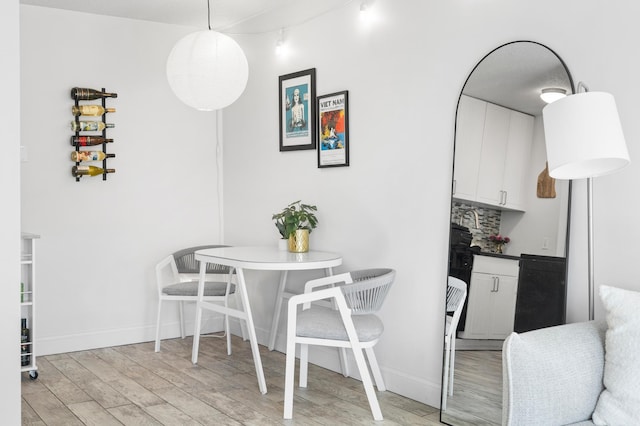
[224, 0, 640, 405]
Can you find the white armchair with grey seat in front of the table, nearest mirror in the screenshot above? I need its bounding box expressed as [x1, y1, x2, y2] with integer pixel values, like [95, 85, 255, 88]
[284, 269, 396, 420]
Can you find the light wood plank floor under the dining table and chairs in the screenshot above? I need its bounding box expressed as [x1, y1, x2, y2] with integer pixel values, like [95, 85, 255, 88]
[22, 337, 440, 426]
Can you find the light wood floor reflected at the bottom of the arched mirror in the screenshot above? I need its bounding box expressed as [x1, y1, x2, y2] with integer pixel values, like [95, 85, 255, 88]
[442, 350, 502, 426]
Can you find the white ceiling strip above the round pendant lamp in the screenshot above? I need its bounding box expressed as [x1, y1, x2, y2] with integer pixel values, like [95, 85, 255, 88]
[20, 0, 353, 33]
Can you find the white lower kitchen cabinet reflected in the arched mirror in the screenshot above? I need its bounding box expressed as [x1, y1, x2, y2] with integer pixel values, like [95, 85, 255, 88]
[459, 255, 519, 340]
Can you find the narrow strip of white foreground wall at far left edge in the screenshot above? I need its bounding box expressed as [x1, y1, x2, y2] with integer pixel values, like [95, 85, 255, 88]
[0, 0, 20, 425]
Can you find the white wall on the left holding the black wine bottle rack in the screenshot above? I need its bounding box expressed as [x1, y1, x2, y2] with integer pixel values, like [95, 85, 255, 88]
[20, 6, 225, 354]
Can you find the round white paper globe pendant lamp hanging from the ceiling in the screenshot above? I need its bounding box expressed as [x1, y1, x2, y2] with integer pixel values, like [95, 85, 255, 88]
[167, 30, 249, 111]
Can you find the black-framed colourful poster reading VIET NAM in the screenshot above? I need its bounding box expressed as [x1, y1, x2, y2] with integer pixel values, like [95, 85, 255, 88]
[318, 90, 349, 167]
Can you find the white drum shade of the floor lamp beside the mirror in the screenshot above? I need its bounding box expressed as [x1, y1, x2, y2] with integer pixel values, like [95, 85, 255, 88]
[542, 92, 630, 179]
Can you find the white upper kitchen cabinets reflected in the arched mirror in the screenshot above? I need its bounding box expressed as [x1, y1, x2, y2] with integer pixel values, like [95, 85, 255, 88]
[453, 95, 534, 211]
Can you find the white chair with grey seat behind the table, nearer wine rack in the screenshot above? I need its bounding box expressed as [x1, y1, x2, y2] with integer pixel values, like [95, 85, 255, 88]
[155, 245, 244, 355]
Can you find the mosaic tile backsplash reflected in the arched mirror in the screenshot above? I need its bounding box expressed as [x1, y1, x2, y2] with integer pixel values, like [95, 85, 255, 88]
[451, 200, 502, 252]
